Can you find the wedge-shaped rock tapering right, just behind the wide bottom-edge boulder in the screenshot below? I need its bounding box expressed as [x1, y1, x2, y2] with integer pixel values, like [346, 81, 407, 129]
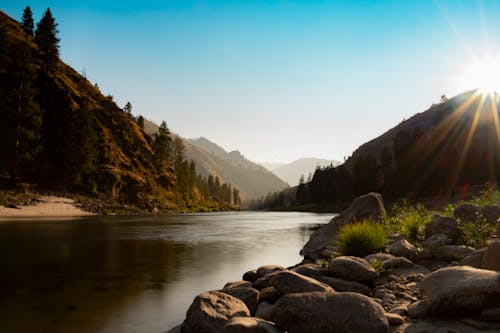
[269, 271, 334, 294]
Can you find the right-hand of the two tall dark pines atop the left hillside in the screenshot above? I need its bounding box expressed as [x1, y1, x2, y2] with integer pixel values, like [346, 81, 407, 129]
[35, 8, 60, 72]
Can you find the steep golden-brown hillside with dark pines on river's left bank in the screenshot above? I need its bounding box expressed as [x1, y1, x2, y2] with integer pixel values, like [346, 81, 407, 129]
[0, 7, 239, 209]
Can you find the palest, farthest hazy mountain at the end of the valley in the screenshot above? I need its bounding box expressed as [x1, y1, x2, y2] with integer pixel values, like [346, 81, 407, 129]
[268, 157, 340, 186]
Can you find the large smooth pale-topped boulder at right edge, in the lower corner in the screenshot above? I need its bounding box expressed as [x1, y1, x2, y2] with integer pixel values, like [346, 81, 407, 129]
[408, 266, 500, 317]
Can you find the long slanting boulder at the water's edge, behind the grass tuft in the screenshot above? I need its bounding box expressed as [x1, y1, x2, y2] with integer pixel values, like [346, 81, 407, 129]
[300, 193, 385, 261]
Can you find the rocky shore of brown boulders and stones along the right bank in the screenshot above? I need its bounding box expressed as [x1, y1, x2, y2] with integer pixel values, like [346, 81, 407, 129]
[169, 193, 500, 333]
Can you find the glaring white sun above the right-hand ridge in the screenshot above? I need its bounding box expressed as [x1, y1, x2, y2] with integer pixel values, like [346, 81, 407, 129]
[459, 55, 500, 95]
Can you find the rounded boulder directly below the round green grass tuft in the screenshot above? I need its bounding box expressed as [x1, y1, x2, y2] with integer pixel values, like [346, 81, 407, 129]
[328, 256, 378, 284]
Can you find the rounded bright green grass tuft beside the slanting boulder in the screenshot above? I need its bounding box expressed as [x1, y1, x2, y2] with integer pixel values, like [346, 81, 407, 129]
[337, 221, 385, 257]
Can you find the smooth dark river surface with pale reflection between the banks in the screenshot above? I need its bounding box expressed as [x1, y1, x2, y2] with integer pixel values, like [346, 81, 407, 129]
[0, 212, 333, 333]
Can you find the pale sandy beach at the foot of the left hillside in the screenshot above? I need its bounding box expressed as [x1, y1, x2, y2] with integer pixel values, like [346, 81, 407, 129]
[0, 196, 93, 219]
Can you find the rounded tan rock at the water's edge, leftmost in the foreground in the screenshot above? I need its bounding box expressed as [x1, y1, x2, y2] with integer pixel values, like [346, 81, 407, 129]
[181, 291, 250, 333]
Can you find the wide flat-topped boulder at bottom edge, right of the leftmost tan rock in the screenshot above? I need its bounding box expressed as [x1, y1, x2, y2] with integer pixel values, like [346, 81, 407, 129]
[271, 292, 389, 333]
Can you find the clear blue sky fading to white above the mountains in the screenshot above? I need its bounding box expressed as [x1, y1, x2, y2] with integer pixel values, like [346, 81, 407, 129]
[0, 0, 500, 162]
